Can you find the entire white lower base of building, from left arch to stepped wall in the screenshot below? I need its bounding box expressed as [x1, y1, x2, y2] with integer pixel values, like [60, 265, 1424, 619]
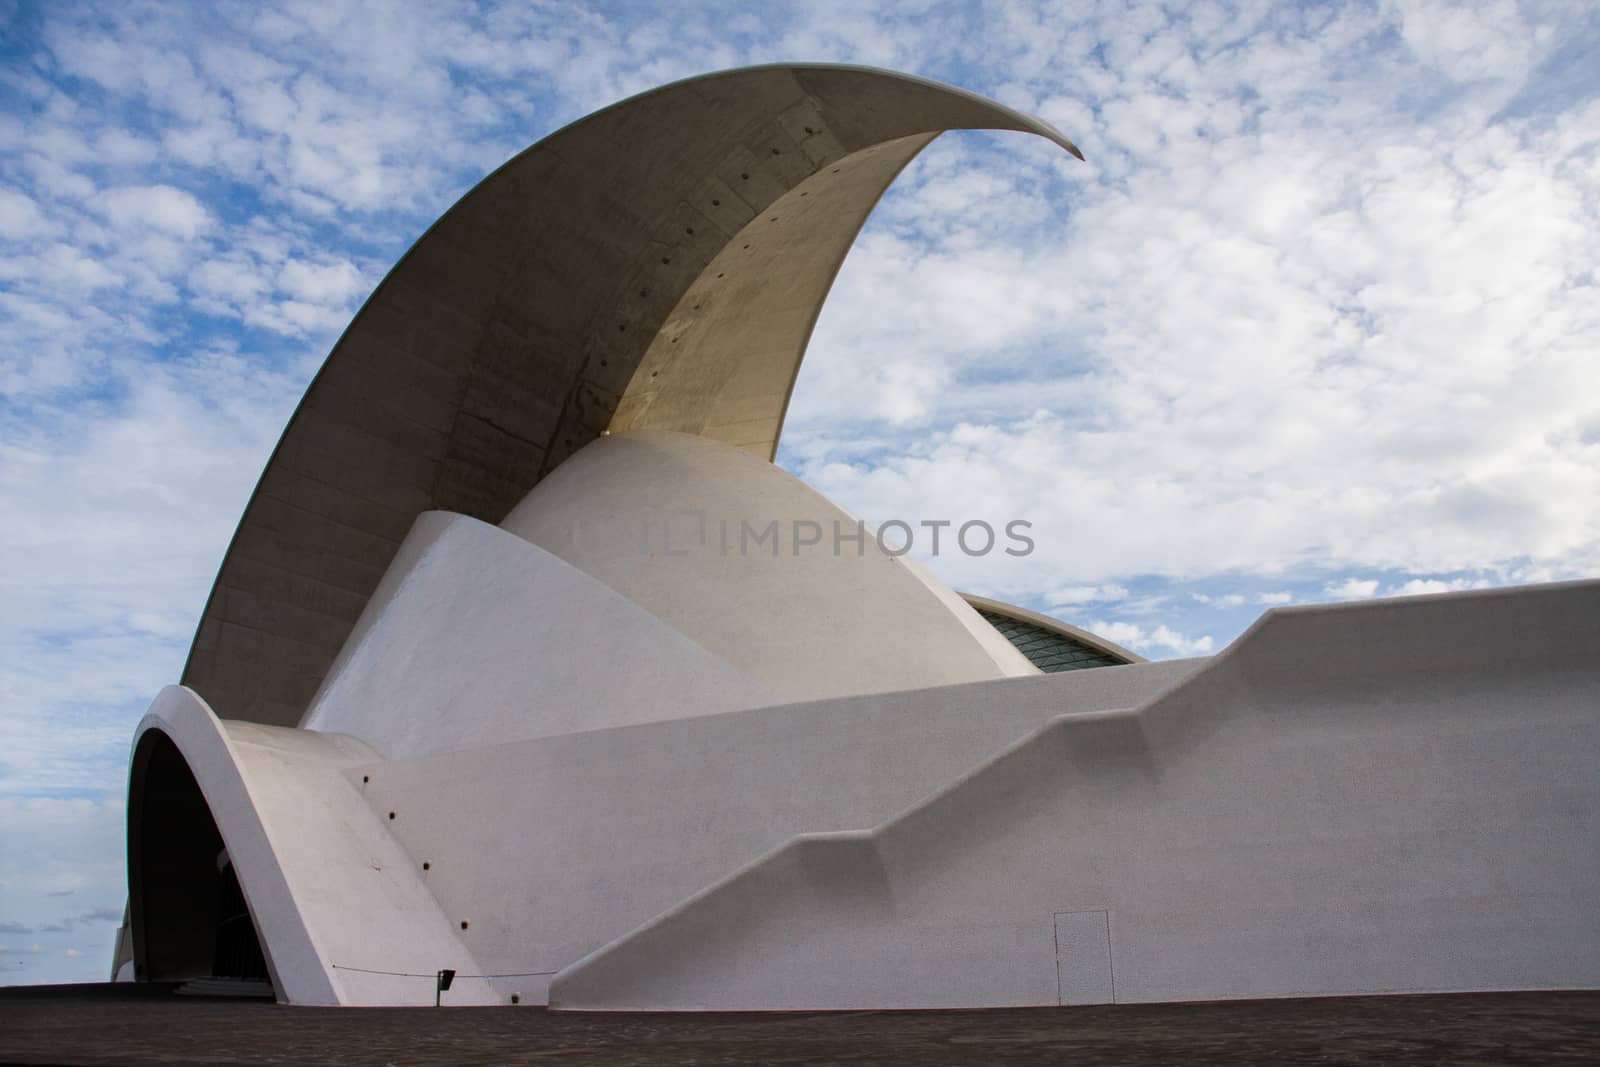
[144, 572, 1600, 1009]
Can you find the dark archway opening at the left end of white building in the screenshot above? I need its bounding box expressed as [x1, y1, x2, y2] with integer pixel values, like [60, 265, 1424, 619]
[128, 729, 270, 982]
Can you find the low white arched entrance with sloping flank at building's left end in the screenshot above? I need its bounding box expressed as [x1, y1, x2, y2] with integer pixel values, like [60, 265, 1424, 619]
[128, 686, 498, 1005]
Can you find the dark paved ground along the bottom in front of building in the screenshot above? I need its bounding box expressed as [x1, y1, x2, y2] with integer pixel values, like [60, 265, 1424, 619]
[0, 987, 1600, 1067]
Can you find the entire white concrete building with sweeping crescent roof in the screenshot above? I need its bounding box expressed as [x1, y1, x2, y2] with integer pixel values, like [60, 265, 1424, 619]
[114, 67, 1600, 1009]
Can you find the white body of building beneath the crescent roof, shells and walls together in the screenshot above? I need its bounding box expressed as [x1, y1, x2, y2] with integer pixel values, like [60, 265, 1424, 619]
[141, 432, 1600, 1009]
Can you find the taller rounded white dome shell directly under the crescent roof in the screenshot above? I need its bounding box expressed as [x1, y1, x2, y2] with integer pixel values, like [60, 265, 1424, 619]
[502, 430, 1037, 702]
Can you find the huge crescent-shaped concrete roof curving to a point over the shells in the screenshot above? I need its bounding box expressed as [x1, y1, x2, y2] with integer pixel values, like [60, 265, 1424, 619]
[182, 66, 1082, 725]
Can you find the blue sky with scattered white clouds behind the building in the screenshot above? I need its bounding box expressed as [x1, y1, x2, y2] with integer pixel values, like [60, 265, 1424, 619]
[0, 0, 1600, 984]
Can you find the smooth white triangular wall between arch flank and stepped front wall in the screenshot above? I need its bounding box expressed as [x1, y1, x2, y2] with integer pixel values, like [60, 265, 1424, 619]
[347, 661, 1205, 997]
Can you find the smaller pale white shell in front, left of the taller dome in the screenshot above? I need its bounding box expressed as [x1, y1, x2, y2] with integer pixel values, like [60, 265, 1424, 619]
[302, 512, 774, 758]
